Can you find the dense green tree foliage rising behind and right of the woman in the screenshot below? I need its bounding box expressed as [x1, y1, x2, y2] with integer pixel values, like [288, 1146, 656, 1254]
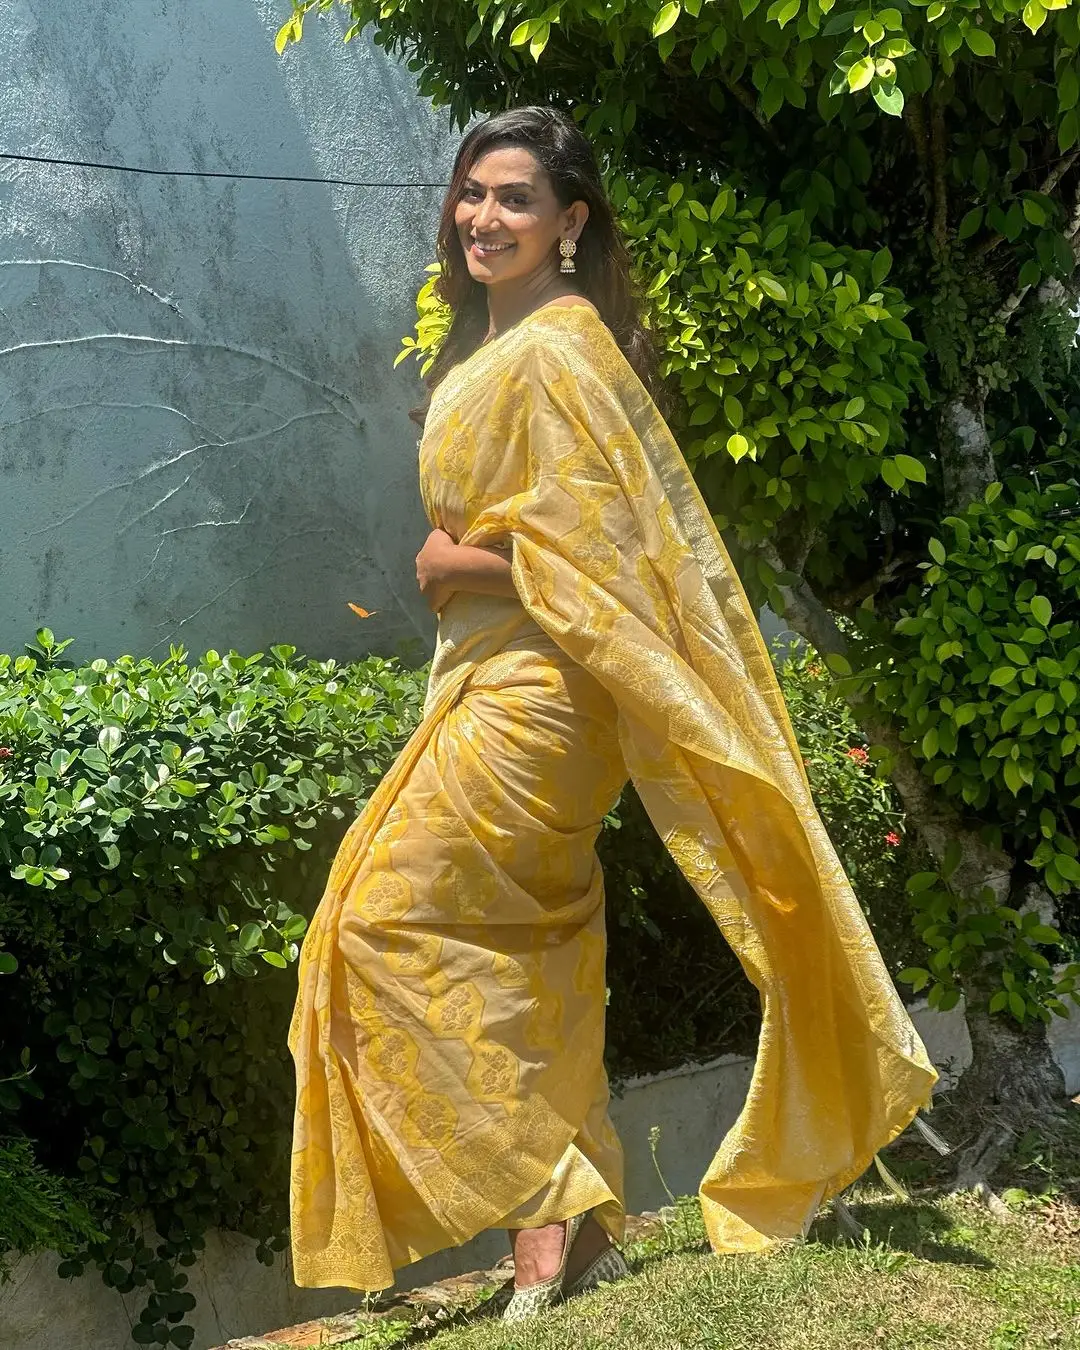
[279, 0, 1080, 1074]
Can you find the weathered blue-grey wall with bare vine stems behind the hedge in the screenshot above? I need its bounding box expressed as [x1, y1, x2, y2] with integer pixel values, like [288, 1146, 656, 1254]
[0, 0, 456, 656]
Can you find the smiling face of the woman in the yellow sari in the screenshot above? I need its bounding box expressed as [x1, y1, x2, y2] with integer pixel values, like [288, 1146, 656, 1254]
[455, 146, 589, 286]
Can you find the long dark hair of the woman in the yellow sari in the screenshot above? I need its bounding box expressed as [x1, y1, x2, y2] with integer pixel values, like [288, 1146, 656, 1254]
[427, 107, 662, 398]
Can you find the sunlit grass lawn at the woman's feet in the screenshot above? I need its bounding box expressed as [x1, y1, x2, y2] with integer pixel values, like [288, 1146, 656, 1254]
[340, 1111, 1080, 1350]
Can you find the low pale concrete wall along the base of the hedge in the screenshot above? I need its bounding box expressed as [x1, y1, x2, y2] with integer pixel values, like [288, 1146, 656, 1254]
[0, 1007, 1080, 1350]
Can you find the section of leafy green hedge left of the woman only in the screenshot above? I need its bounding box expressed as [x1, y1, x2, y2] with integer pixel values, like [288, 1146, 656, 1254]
[0, 630, 424, 1346]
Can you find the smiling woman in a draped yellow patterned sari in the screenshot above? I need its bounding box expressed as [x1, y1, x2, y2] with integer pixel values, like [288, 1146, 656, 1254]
[290, 108, 936, 1319]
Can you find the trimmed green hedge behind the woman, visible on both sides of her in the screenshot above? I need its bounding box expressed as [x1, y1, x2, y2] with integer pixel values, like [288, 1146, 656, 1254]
[0, 630, 909, 1347]
